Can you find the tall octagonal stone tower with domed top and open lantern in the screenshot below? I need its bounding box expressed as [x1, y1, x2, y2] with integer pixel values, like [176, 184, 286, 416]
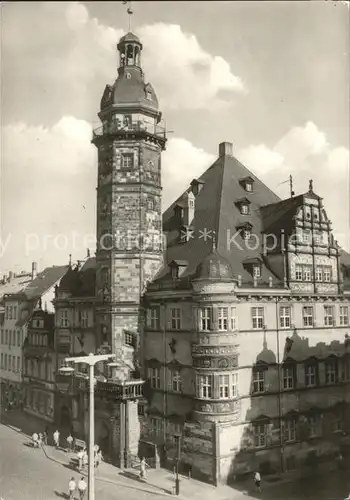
[92, 32, 166, 374]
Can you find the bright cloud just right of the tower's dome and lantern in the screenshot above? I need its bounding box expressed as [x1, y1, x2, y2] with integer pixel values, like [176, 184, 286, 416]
[139, 23, 245, 109]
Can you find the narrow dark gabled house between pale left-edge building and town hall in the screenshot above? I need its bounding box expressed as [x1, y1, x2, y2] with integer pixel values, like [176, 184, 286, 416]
[23, 301, 56, 422]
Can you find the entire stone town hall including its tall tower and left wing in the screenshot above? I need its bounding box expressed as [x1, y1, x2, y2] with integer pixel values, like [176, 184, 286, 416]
[51, 28, 350, 484]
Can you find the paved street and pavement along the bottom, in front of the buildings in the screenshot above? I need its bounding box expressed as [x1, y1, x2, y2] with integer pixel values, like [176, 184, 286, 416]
[0, 418, 350, 500]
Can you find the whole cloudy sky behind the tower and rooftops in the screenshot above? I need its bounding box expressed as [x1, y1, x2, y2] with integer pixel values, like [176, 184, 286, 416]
[0, 1, 350, 272]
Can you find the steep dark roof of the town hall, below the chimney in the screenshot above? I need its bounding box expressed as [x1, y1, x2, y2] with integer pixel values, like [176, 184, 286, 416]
[160, 145, 280, 282]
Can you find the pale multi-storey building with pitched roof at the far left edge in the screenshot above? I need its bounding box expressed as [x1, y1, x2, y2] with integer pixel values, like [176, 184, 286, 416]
[0, 262, 68, 406]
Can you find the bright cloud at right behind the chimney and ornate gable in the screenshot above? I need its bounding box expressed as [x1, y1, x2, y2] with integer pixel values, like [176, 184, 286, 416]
[238, 122, 350, 250]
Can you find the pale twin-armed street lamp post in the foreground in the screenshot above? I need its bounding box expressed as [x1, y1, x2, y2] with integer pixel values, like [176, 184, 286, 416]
[59, 352, 115, 500]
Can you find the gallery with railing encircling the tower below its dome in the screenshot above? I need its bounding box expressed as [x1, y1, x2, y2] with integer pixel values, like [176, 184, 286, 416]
[93, 120, 166, 140]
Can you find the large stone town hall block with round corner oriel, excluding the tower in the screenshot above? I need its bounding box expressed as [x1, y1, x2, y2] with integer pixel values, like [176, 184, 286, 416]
[143, 143, 350, 483]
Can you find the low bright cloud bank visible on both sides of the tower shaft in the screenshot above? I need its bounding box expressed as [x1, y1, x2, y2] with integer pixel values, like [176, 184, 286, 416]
[0, 116, 214, 271]
